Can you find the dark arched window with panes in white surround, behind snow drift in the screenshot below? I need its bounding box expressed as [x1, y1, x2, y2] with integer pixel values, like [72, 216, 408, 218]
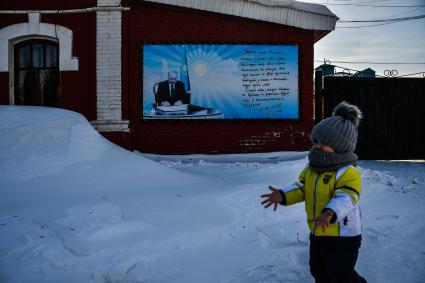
[14, 39, 60, 107]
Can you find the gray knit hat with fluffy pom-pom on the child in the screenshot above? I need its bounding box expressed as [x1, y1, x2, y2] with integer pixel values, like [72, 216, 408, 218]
[311, 101, 363, 152]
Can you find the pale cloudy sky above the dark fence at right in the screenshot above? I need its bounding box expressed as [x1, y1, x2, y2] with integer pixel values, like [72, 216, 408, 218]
[303, 0, 425, 77]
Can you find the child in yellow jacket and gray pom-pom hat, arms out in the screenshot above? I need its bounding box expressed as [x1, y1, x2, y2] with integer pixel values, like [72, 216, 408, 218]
[261, 101, 366, 283]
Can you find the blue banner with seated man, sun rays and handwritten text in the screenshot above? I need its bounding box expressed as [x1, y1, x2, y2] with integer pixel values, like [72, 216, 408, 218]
[140, 44, 299, 119]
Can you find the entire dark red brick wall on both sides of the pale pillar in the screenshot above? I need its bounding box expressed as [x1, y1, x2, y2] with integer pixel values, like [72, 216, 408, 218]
[0, 0, 314, 154]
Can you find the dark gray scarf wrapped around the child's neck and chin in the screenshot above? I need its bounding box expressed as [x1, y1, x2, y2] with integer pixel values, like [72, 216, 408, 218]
[308, 149, 358, 173]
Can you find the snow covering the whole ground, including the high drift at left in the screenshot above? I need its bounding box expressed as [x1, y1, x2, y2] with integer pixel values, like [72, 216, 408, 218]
[0, 106, 425, 283]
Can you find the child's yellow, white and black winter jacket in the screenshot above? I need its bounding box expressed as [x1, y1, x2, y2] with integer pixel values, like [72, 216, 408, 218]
[281, 165, 362, 237]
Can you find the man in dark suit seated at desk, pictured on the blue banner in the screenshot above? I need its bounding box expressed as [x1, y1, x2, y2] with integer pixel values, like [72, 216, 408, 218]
[155, 71, 187, 106]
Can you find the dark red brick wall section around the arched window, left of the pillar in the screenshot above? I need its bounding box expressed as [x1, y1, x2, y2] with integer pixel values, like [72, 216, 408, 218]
[0, 0, 96, 120]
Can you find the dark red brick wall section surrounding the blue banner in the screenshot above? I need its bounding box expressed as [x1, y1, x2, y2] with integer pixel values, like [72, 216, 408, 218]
[123, 0, 314, 154]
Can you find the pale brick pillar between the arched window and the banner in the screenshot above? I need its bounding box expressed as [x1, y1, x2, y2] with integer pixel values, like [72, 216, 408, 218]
[92, 0, 130, 132]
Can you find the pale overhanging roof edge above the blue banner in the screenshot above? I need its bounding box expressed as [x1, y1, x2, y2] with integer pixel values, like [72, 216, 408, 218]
[145, 0, 338, 41]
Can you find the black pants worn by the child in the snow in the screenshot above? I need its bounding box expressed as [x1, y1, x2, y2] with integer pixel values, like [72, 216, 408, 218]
[310, 235, 366, 283]
